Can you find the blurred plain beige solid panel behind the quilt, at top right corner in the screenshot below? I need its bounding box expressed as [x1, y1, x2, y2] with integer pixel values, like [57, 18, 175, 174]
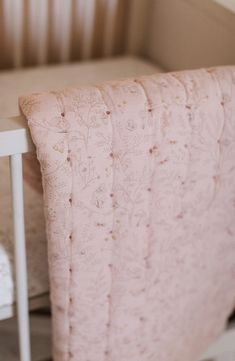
[145, 0, 235, 70]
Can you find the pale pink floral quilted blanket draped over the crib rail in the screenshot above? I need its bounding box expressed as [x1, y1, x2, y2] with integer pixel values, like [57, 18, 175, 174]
[20, 67, 235, 361]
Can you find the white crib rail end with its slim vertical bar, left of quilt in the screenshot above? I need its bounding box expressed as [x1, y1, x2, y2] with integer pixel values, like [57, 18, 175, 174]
[0, 117, 34, 361]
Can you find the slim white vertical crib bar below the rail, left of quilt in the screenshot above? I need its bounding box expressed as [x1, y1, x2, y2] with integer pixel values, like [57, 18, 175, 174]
[10, 154, 31, 361]
